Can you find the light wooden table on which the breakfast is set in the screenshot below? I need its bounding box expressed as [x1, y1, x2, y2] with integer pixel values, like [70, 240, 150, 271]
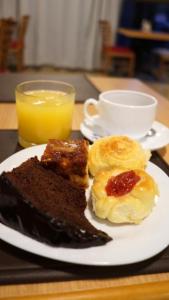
[0, 76, 169, 300]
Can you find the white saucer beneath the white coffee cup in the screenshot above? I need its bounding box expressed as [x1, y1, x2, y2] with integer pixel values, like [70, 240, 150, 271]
[80, 121, 169, 151]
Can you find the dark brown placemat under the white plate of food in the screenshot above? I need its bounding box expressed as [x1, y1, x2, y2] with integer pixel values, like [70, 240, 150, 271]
[0, 130, 169, 284]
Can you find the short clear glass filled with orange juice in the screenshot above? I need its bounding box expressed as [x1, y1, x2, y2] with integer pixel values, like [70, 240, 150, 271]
[15, 80, 75, 147]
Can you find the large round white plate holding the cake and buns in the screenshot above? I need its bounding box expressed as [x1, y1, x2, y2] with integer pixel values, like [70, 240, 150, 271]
[0, 145, 169, 266]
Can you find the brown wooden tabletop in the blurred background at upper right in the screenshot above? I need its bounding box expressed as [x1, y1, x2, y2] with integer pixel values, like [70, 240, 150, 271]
[117, 28, 169, 41]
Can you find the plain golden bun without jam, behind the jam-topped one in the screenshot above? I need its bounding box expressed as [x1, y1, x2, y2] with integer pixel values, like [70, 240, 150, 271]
[88, 136, 151, 176]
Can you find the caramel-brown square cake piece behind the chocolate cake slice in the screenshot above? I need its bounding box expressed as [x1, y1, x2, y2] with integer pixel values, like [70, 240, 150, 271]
[41, 139, 88, 187]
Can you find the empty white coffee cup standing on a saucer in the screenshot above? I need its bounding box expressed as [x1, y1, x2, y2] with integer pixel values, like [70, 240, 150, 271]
[84, 90, 157, 139]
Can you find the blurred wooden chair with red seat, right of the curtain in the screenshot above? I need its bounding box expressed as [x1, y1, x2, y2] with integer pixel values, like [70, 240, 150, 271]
[99, 20, 135, 77]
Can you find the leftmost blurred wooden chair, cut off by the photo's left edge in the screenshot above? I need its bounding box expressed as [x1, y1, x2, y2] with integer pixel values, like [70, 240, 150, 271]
[0, 18, 16, 72]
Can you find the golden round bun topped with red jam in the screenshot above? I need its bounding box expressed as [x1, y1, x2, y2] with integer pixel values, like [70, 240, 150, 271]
[92, 169, 158, 224]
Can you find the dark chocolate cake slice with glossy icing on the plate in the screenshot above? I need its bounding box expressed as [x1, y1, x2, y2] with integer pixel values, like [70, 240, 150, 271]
[0, 157, 111, 248]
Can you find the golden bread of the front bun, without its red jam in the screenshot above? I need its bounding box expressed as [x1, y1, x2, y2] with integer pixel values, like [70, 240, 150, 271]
[92, 169, 158, 224]
